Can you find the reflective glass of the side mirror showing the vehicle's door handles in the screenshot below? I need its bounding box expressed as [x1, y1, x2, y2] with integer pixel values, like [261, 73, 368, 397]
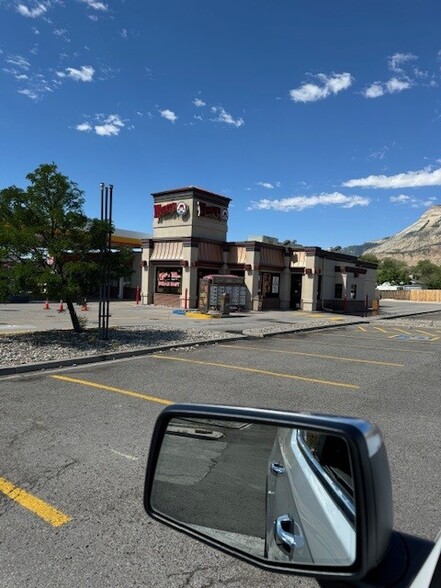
[151, 418, 356, 566]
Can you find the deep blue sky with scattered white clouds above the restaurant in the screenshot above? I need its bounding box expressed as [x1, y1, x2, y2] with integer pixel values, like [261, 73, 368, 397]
[0, 0, 441, 247]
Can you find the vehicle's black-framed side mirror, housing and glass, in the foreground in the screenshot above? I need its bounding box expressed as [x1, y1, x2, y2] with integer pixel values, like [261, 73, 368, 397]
[144, 405, 392, 580]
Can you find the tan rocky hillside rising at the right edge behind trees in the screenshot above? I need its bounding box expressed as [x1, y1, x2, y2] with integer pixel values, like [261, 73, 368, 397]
[342, 205, 441, 265]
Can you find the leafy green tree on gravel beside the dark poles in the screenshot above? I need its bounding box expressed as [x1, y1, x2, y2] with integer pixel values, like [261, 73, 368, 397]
[0, 163, 133, 332]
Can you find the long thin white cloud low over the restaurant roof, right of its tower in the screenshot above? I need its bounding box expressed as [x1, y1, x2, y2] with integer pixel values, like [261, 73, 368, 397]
[248, 192, 370, 212]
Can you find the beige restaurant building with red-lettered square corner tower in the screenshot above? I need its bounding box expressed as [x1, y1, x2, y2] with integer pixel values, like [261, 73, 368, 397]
[141, 186, 377, 312]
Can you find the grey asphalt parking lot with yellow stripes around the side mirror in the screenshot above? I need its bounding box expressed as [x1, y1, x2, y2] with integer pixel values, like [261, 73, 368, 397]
[0, 321, 441, 587]
